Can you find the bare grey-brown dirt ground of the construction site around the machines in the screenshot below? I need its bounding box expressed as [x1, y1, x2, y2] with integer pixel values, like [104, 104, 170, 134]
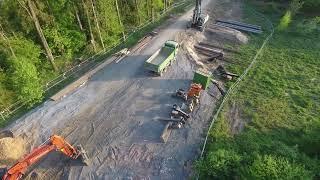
[1, 0, 246, 179]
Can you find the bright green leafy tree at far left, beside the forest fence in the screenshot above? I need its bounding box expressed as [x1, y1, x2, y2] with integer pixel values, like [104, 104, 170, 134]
[2, 36, 43, 106]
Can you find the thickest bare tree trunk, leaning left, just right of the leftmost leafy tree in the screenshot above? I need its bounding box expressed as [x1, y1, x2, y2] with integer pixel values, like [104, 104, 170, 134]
[27, 0, 58, 71]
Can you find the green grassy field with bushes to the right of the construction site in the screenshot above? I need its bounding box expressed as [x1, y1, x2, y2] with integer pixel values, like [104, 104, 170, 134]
[195, 2, 320, 179]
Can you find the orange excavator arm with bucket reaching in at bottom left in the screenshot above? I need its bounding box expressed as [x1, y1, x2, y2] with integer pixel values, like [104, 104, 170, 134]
[0, 135, 88, 180]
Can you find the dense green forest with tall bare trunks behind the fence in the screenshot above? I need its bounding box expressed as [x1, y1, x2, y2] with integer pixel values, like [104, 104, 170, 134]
[0, 0, 173, 111]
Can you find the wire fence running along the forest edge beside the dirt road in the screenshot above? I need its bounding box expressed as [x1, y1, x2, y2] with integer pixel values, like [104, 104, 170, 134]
[0, 0, 188, 124]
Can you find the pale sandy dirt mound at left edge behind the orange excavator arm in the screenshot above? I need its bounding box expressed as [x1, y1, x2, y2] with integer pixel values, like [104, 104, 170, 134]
[0, 137, 26, 165]
